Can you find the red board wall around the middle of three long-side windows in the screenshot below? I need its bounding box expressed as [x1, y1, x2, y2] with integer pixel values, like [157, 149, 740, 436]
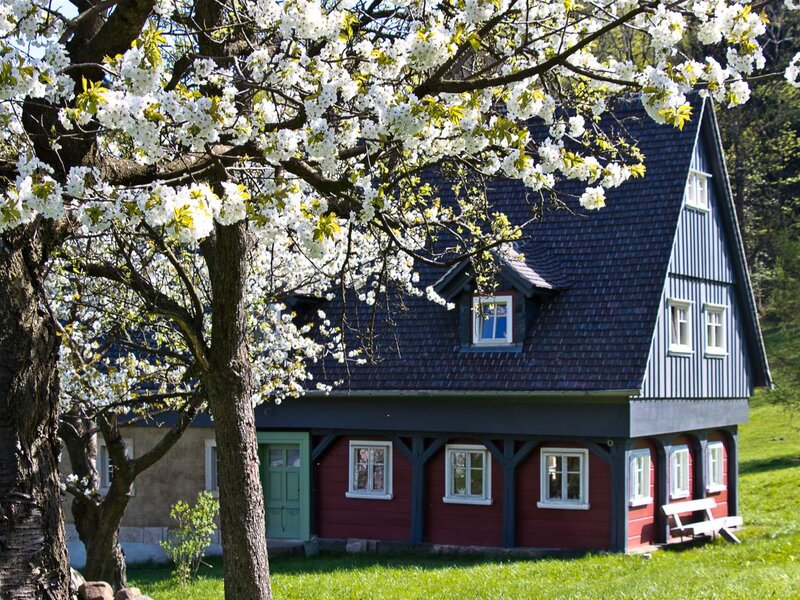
[425, 439, 503, 546]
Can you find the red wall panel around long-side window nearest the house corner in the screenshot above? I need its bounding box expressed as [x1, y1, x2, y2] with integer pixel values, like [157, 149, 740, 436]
[517, 441, 611, 549]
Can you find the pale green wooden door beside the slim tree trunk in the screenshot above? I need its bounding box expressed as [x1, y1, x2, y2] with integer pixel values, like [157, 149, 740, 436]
[261, 444, 303, 538]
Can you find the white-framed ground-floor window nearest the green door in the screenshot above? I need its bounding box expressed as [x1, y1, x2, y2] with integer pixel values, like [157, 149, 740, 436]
[345, 441, 392, 500]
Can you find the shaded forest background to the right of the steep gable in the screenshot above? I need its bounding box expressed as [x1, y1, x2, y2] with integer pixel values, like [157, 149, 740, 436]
[718, 3, 800, 409]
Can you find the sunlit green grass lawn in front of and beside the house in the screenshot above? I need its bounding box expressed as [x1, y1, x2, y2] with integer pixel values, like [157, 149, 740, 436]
[129, 398, 800, 600]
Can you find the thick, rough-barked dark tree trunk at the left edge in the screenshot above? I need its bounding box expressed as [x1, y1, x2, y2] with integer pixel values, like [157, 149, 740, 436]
[0, 221, 69, 599]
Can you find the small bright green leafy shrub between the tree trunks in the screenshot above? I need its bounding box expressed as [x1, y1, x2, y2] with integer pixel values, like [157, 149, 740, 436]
[161, 492, 219, 585]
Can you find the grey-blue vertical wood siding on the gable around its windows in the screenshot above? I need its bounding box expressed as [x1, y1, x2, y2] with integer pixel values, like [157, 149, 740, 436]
[641, 140, 753, 398]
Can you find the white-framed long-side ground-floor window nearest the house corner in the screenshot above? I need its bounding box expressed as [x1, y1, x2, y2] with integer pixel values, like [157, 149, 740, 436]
[537, 448, 589, 509]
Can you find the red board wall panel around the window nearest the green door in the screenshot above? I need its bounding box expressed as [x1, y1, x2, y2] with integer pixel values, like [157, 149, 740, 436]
[314, 436, 411, 541]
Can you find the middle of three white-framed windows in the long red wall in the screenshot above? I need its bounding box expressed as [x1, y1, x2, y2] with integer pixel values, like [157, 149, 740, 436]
[442, 445, 492, 504]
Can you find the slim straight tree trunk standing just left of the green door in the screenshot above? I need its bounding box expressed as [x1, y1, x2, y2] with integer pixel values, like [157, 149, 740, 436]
[202, 223, 272, 600]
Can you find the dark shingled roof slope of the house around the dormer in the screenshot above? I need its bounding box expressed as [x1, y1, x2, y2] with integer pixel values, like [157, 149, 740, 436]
[310, 94, 764, 392]
